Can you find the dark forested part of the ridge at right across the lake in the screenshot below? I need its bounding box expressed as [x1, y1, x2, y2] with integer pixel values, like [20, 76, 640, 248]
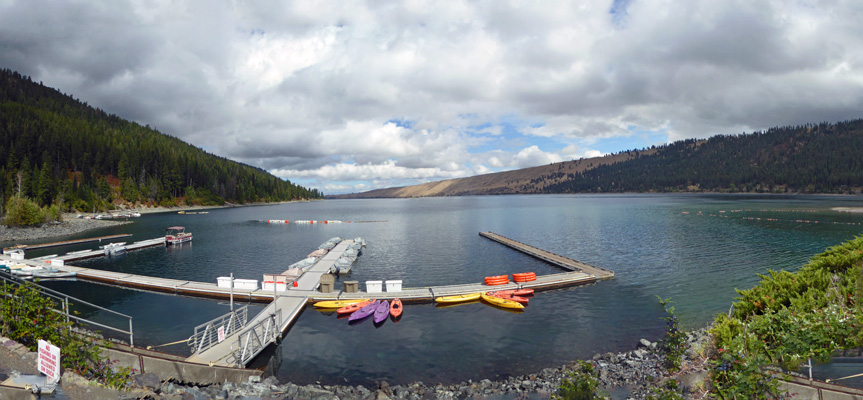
[540, 119, 863, 193]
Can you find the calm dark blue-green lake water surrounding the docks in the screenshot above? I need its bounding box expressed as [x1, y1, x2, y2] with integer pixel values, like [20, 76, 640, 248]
[5, 195, 863, 385]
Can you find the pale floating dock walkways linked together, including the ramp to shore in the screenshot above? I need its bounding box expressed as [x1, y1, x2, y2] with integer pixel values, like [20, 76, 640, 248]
[5, 232, 614, 366]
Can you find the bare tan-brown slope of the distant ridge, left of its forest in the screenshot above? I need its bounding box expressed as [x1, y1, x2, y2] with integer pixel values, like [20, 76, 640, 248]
[331, 150, 655, 199]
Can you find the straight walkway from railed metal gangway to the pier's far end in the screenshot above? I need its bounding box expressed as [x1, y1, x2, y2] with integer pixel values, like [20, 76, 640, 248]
[186, 239, 354, 368]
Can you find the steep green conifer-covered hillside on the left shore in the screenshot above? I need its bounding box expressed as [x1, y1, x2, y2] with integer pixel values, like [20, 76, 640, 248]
[0, 70, 321, 216]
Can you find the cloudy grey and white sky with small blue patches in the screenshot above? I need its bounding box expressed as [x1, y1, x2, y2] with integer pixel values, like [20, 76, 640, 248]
[0, 0, 863, 194]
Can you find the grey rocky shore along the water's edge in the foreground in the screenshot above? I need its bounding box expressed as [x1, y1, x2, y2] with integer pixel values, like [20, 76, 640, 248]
[0, 329, 709, 400]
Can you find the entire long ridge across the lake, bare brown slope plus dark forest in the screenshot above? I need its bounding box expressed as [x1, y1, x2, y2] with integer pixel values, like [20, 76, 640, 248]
[329, 119, 863, 198]
